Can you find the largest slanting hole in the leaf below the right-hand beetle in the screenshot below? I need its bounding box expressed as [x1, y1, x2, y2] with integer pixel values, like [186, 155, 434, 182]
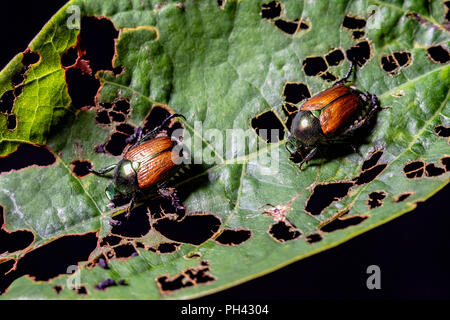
[305, 182, 353, 216]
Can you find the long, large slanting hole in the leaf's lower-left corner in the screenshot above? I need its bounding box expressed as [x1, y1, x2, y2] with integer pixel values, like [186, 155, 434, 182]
[0, 232, 97, 292]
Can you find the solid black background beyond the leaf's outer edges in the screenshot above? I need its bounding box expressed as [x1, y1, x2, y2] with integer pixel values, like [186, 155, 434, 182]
[0, 0, 450, 300]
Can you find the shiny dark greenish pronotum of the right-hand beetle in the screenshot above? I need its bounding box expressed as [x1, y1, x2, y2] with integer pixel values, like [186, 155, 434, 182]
[291, 110, 323, 146]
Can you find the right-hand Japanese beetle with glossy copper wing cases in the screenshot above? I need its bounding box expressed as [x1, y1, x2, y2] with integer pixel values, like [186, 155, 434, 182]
[286, 62, 380, 168]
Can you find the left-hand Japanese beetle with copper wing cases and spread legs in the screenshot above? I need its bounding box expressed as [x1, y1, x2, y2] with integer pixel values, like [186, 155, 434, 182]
[90, 114, 184, 216]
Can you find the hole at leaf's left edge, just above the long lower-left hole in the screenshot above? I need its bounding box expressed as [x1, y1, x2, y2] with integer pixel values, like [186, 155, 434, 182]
[0, 206, 34, 254]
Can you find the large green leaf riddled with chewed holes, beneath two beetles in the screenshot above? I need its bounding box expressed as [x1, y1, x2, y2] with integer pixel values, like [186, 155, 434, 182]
[0, 0, 450, 299]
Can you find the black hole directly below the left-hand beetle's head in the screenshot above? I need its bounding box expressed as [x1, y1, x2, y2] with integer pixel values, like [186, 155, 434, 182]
[111, 206, 151, 238]
